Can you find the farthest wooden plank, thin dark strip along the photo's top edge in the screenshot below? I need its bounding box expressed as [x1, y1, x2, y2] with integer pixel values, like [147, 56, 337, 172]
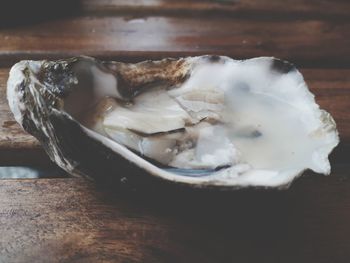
[0, 0, 350, 20]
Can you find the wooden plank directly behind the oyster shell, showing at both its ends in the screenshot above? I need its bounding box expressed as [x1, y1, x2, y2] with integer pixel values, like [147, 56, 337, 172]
[0, 68, 350, 165]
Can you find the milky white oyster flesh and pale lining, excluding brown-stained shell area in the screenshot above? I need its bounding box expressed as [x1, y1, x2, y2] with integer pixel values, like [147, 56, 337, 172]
[78, 58, 339, 186]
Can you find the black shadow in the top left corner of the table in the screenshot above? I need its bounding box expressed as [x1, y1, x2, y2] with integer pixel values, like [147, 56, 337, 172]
[0, 0, 81, 28]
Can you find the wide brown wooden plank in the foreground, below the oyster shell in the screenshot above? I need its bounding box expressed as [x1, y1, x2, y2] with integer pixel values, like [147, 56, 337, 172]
[0, 174, 350, 263]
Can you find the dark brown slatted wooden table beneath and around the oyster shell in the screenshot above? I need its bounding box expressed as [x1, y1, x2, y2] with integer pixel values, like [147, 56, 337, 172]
[0, 0, 350, 263]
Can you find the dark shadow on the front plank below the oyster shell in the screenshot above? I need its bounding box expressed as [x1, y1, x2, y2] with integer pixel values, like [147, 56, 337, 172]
[87, 143, 350, 262]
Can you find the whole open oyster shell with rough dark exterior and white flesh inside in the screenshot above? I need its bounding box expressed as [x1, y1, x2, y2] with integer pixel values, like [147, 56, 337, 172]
[7, 56, 339, 188]
